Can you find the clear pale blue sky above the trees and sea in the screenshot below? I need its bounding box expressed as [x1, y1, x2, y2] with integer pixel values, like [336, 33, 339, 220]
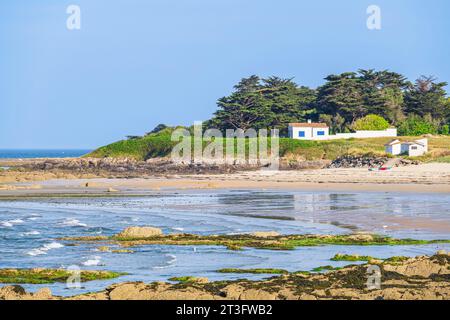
[0, 0, 450, 149]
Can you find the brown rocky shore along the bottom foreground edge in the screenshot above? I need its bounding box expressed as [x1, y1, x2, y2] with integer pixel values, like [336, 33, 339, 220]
[0, 252, 450, 300]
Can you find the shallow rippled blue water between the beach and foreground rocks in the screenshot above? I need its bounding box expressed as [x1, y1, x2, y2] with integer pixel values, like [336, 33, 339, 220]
[0, 190, 450, 295]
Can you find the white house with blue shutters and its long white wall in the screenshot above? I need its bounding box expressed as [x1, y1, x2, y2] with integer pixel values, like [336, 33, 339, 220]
[289, 120, 397, 140]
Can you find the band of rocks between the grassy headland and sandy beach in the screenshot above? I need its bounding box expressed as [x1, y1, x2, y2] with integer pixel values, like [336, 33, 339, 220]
[0, 155, 412, 177]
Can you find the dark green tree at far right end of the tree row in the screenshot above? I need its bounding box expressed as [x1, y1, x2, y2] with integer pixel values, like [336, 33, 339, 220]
[405, 76, 447, 121]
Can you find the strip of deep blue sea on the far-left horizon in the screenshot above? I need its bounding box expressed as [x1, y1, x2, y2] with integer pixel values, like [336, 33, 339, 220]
[0, 149, 92, 159]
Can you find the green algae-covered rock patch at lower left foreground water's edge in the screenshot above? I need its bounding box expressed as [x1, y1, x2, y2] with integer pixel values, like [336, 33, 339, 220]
[0, 269, 125, 284]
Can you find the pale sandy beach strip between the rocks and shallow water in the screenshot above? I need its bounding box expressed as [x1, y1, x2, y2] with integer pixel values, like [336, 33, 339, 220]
[0, 163, 450, 197]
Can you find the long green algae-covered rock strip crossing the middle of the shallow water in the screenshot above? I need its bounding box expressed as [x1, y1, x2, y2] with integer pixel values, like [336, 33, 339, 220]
[61, 234, 450, 250]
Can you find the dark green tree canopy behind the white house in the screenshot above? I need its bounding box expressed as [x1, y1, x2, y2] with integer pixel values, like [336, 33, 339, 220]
[207, 69, 450, 134]
